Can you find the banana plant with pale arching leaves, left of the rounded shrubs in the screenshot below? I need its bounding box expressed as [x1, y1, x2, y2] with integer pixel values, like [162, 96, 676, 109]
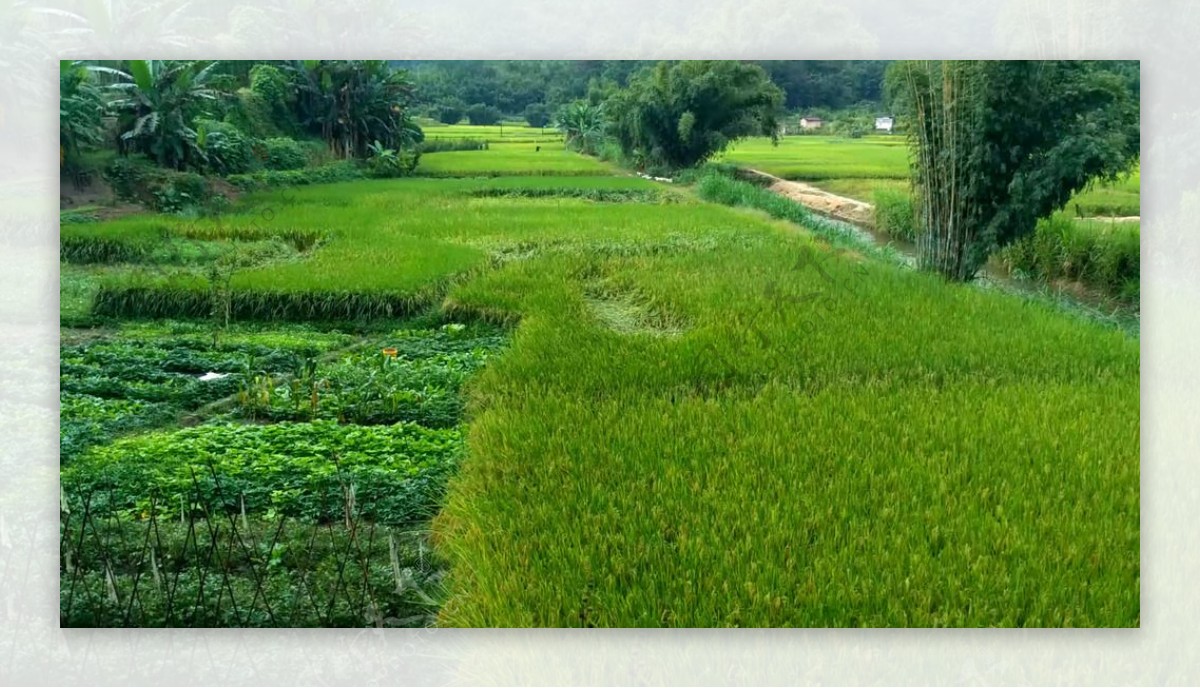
[109, 60, 217, 169]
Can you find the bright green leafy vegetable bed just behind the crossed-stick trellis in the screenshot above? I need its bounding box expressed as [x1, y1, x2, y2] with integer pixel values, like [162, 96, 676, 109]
[62, 420, 462, 525]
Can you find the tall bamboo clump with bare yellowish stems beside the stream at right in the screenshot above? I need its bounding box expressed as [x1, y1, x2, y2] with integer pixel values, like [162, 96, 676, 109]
[887, 60, 1140, 280]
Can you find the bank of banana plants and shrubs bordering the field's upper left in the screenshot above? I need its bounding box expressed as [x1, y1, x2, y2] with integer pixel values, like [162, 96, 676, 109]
[60, 60, 424, 206]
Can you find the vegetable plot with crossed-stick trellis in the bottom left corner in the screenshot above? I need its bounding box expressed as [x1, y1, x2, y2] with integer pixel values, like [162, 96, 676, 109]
[60, 509, 443, 628]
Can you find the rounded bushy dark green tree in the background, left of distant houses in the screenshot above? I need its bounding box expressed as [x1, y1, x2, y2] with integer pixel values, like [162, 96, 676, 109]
[605, 60, 784, 168]
